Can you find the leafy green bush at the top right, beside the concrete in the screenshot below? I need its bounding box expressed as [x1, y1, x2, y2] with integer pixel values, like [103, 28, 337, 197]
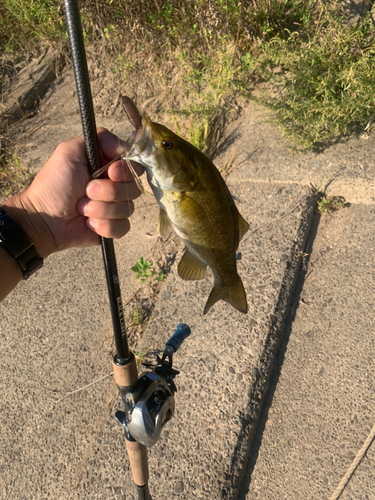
[250, 3, 375, 149]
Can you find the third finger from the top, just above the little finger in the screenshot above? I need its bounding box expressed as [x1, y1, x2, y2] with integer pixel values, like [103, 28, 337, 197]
[77, 198, 134, 220]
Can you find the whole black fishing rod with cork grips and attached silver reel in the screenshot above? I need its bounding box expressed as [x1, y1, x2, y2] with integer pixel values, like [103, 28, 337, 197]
[64, 0, 191, 500]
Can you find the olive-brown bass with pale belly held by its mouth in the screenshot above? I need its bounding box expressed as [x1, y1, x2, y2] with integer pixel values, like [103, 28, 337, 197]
[126, 100, 250, 314]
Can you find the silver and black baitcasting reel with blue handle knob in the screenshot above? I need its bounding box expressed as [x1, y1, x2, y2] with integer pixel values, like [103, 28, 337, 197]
[115, 323, 191, 447]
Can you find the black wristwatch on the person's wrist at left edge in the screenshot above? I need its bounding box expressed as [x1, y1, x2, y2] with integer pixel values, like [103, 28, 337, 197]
[0, 208, 43, 280]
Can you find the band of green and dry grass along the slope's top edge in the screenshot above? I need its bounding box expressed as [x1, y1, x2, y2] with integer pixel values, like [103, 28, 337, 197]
[0, 0, 375, 156]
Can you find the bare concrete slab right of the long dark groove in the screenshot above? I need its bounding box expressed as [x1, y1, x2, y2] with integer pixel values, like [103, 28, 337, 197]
[242, 204, 375, 500]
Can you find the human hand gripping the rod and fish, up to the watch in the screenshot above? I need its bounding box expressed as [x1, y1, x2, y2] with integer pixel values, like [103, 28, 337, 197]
[3, 129, 143, 258]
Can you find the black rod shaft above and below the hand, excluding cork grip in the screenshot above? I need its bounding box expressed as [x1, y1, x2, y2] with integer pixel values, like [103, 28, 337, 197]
[64, 0, 131, 363]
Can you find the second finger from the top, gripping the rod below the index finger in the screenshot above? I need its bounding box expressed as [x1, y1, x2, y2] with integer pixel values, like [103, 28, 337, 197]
[86, 179, 141, 202]
